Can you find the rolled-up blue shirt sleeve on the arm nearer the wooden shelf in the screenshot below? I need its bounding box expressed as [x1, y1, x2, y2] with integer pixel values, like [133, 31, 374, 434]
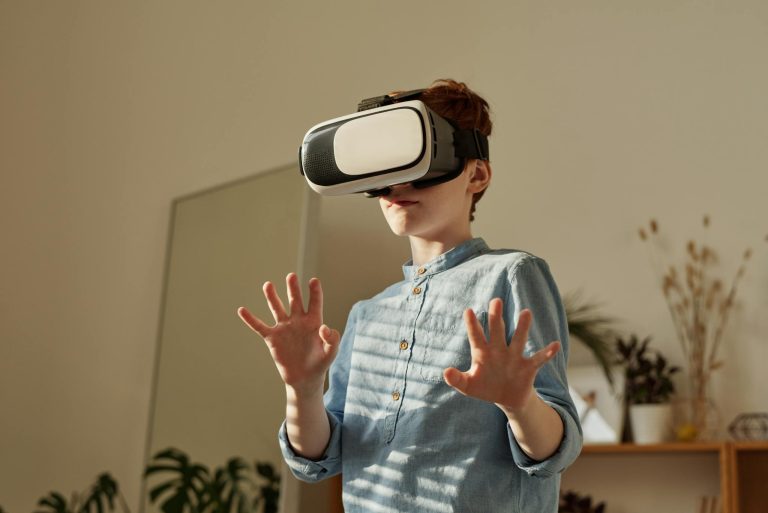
[507, 256, 582, 477]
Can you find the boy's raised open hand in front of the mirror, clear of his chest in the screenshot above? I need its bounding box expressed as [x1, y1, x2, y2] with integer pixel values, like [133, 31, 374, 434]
[237, 273, 341, 391]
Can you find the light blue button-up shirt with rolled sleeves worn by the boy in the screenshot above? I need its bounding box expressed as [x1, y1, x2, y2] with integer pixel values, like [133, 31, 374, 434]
[279, 238, 581, 513]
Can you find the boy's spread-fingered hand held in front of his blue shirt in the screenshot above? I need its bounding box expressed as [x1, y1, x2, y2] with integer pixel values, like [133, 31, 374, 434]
[443, 298, 560, 411]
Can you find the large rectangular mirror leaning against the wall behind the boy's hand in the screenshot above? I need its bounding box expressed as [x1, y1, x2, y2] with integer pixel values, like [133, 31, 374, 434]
[142, 165, 316, 511]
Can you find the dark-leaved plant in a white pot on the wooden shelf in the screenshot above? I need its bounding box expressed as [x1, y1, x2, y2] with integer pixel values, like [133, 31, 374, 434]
[616, 335, 680, 444]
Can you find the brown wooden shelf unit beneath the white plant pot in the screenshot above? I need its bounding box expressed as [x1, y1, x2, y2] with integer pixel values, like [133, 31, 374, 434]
[580, 441, 768, 513]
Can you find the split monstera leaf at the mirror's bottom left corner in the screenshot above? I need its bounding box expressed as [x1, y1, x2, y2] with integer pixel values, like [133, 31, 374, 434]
[144, 448, 210, 513]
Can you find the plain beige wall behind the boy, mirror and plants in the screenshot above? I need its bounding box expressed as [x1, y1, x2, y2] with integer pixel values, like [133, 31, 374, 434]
[0, 0, 768, 513]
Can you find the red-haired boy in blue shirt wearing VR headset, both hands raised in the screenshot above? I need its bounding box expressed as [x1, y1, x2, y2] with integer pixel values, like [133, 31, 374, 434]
[238, 80, 581, 513]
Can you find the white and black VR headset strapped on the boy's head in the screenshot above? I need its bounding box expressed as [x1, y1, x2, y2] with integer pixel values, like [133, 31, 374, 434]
[299, 89, 488, 197]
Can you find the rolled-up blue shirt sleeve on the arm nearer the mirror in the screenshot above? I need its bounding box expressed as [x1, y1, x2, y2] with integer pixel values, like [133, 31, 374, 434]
[277, 304, 358, 482]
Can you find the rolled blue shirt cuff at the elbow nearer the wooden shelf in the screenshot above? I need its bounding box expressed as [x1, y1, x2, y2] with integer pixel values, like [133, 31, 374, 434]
[507, 402, 582, 478]
